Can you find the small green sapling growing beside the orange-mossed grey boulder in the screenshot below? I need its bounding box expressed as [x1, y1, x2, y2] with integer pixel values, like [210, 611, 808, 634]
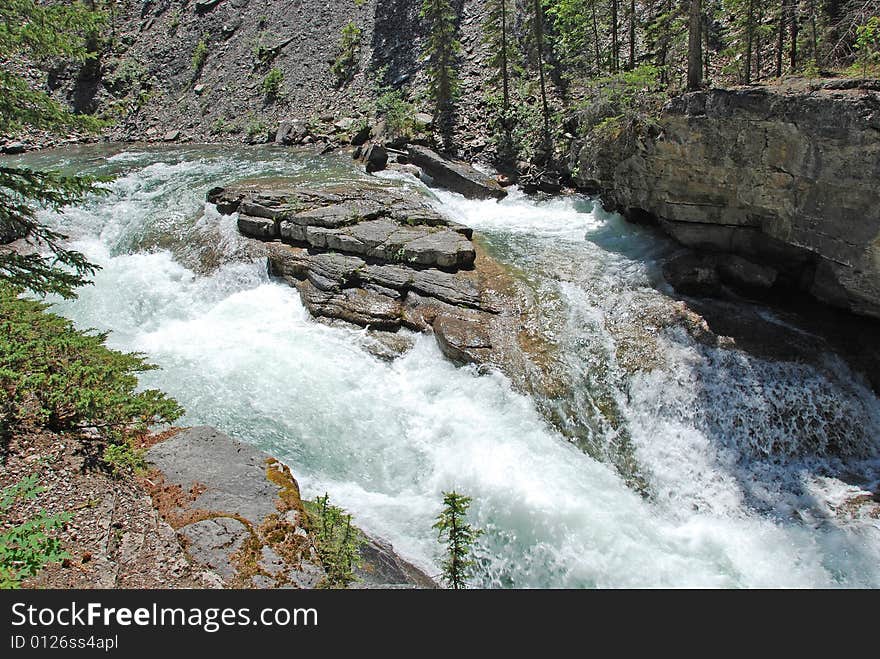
[307, 494, 364, 588]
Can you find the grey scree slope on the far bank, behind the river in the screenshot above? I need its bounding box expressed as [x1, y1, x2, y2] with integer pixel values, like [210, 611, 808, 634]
[49, 0, 489, 152]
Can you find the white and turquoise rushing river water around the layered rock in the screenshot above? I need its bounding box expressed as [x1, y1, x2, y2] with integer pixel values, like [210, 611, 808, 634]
[10, 147, 880, 587]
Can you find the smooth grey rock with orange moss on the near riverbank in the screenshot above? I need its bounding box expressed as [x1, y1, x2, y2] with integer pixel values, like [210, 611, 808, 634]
[146, 427, 436, 588]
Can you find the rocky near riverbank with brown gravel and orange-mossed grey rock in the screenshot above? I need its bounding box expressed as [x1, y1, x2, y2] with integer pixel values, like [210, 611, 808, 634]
[0, 427, 437, 589]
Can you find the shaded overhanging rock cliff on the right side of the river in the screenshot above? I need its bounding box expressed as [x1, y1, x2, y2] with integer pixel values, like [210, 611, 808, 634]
[575, 81, 880, 317]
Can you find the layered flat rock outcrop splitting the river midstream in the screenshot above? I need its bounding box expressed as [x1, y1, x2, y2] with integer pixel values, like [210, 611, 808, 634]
[216, 182, 527, 382]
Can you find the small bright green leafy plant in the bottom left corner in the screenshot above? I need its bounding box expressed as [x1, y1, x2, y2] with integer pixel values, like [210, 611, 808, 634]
[0, 476, 70, 589]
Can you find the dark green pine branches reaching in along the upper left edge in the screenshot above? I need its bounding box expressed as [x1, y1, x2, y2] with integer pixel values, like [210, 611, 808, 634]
[0, 0, 103, 298]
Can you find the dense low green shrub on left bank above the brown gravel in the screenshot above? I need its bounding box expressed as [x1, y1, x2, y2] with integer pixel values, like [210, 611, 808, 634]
[0, 284, 183, 444]
